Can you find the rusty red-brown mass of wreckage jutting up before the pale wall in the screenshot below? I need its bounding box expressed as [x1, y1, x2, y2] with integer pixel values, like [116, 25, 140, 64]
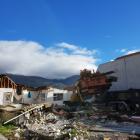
[75, 69, 117, 102]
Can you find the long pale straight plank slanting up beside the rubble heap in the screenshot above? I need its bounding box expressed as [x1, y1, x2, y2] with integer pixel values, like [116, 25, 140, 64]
[3, 104, 44, 124]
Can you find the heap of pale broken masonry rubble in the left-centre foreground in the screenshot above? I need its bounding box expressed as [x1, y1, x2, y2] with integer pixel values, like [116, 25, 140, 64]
[22, 110, 91, 139]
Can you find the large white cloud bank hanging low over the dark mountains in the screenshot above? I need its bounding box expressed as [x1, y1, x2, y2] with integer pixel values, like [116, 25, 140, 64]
[0, 40, 97, 78]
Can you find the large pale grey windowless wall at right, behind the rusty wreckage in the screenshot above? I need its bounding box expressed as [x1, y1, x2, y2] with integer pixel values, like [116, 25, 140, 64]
[97, 54, 140, 91]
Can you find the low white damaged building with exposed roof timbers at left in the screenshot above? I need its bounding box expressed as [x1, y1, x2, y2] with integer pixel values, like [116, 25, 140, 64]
[0, 75, 73, 105]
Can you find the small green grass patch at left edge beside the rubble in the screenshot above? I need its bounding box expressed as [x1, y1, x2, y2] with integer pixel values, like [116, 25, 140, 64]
[0, 124, 16, 136]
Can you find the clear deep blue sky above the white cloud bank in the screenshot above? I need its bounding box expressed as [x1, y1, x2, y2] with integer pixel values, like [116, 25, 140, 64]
[0, 0, 140, 77]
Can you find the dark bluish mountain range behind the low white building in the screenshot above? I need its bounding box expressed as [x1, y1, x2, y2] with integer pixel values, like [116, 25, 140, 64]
[6, 74, 79, 88]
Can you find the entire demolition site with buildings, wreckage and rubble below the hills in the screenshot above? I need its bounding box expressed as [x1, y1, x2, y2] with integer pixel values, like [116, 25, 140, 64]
[0, 52, 140, 140]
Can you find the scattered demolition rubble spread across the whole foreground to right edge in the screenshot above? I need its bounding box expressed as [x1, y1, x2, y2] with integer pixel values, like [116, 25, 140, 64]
[0, 104, 140, 140]
